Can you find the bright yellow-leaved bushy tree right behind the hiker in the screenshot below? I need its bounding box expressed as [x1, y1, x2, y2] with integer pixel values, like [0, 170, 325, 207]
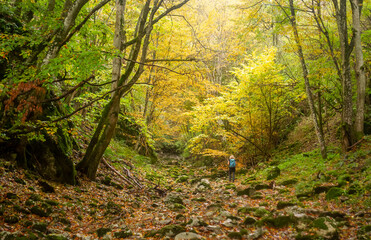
[189, 48, 304, 166]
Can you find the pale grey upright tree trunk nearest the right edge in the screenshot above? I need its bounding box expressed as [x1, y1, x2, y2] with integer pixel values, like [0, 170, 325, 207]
[350, 0, 366, 141]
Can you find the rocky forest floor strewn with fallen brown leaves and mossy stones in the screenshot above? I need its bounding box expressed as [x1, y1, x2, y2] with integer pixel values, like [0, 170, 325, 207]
[0, 152, 371, 240]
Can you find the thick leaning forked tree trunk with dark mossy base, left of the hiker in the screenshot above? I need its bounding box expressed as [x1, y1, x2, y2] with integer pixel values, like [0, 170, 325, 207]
[76, 0, 189, 179]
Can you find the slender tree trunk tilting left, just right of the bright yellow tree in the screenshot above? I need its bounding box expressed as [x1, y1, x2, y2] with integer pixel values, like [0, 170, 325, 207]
[289, 0, 327, 159]
